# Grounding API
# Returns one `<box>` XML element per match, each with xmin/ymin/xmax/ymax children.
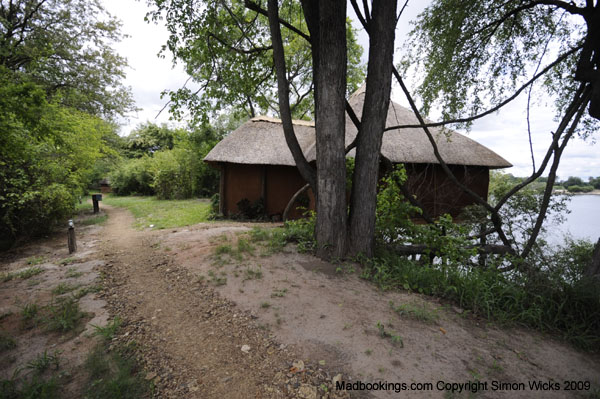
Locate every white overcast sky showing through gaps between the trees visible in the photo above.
<box><xmin>102</xmin><ymin>0</ymin><xmax>600</xmax><ymax>180</ymax></box>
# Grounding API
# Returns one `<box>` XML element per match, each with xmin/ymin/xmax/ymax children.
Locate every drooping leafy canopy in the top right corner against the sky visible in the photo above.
<box><xmin>403</xmin><ymin>0</ymin><xmax>600</xmax><ymax>132</ymax></box>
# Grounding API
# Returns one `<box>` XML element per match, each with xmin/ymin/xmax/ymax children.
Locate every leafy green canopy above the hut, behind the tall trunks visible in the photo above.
<box><xmin>147</xmin><ymin>0</ymin><xmax>364</xmax><ymax>121</ymax></box>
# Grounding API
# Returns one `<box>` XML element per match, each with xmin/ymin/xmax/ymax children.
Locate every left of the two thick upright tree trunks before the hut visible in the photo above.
<box><xmin>312</xmin><ymin>0</ymin><xmax>347</xmax><ymax>258</ymax></box>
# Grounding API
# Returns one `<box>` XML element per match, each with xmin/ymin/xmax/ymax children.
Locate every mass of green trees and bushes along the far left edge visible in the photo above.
<box><xmin>0</xmin><ymin>0</ymin><xmax>133</xmax><ymax>249</ymax></box>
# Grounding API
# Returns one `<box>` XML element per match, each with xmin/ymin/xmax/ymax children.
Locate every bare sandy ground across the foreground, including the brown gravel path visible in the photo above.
<box><xmin>0</xmin><ymin>206</ymin><xmax>600</xmax><ymax>399</ymax></box>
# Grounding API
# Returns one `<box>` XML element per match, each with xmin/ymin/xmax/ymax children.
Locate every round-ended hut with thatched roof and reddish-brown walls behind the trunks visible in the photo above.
<box><xmin>204</xmin><ymin>88</ymin><xmax>512</xmax><ymax>220</ymax></box>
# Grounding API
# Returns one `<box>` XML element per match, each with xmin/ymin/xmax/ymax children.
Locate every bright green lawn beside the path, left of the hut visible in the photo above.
<box><xmin>103</xmin><ymin>195</ymin><xmax>210</xmax><ymax>229</ymax></box>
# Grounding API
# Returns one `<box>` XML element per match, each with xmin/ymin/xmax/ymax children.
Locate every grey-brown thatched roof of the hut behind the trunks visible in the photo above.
<box><xmin>204</xmin><ymin>86</ymin><xmax>512</xmax><ymax>169</ymax></box>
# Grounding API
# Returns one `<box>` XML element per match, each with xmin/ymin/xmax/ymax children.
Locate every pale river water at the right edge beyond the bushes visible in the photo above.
<box><xmin>548</xmin><ymin>195</ymin><xmax>600</xmax><ymax>244</ymax></box>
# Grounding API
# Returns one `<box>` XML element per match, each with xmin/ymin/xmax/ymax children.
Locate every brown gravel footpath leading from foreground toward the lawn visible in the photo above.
<box><xmin>103</xmin><ymin>206</ymin><xmax>346</xmax><ymax>398</ymax></box>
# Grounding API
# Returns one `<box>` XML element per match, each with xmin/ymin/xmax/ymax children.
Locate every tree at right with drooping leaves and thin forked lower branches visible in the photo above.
<box><xmin>397</xmin><ymin>0</ymin><xmax>600</xmax><ymax>266</ymax></box>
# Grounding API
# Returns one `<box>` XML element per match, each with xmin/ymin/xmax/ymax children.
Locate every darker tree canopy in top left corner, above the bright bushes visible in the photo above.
<box><xmin>0</xmin><ymin>0</ymin><xmax>133</xmax><ymax>118</ymax></box>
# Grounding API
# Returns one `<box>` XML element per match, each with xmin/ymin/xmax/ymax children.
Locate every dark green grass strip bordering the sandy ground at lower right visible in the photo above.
<box><xmin>363</xmin><ymin>254</ymin><xmax>600</xmax><ymax>351</ymax></box>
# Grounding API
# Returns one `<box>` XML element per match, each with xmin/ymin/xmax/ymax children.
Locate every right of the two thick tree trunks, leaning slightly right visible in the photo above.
<box><xmin>349</xmin><ymin>0</ymin><xmax>396</xmax><ymax>257</ymax></box>
